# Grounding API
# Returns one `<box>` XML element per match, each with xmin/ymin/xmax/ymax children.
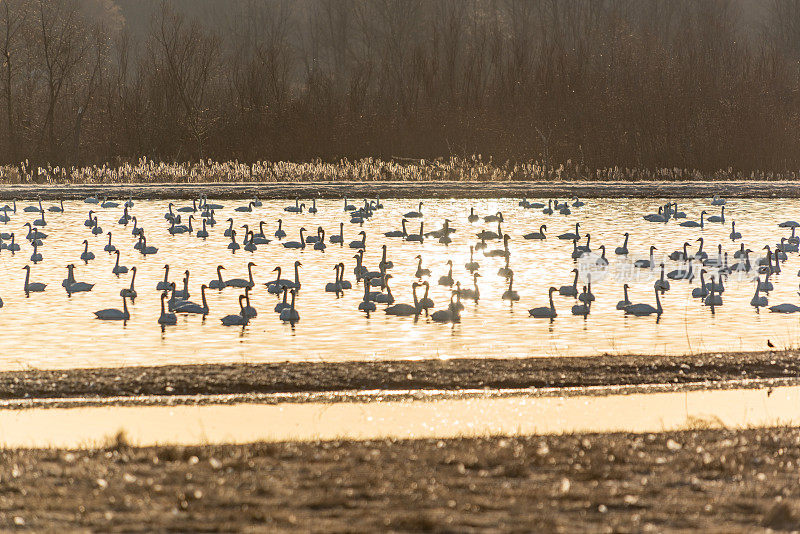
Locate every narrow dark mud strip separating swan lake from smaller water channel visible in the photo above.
<box><xmin>0</xmin><ymin>351</ymin><xmax>800</xmax><ymax>399</ymax></box>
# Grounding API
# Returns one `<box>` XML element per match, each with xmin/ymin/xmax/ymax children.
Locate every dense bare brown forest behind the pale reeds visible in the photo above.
<box><xmin>0</xmin><ymin>0</ymin><xmax>800</xmax><ymax>171</ymax></box>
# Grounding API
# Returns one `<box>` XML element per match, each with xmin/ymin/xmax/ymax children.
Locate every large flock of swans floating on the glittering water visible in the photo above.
<box><xmin>0</xmin><ymin>191</ymin><xmax>800</xmax><ymax>326</ymax></box>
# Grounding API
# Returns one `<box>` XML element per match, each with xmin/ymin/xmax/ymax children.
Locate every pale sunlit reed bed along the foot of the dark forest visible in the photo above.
<box><xmin>0</xmin><ymin>155</ymin><xmax>800</xmax><ymax>185</ymax></box>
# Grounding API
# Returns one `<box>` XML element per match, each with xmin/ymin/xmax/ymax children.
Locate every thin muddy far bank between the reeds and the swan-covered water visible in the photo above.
<box><xmin>0</xmin><ymin>181</ymin><xmax>800</xmax><ymax>200</ymax></box>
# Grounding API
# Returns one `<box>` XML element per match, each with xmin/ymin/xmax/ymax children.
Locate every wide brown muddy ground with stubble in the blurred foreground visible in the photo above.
<box><xmin>0</xmin><ymin>428</ymin><xmax>800</xmax><ymax>532</ymax></box>
